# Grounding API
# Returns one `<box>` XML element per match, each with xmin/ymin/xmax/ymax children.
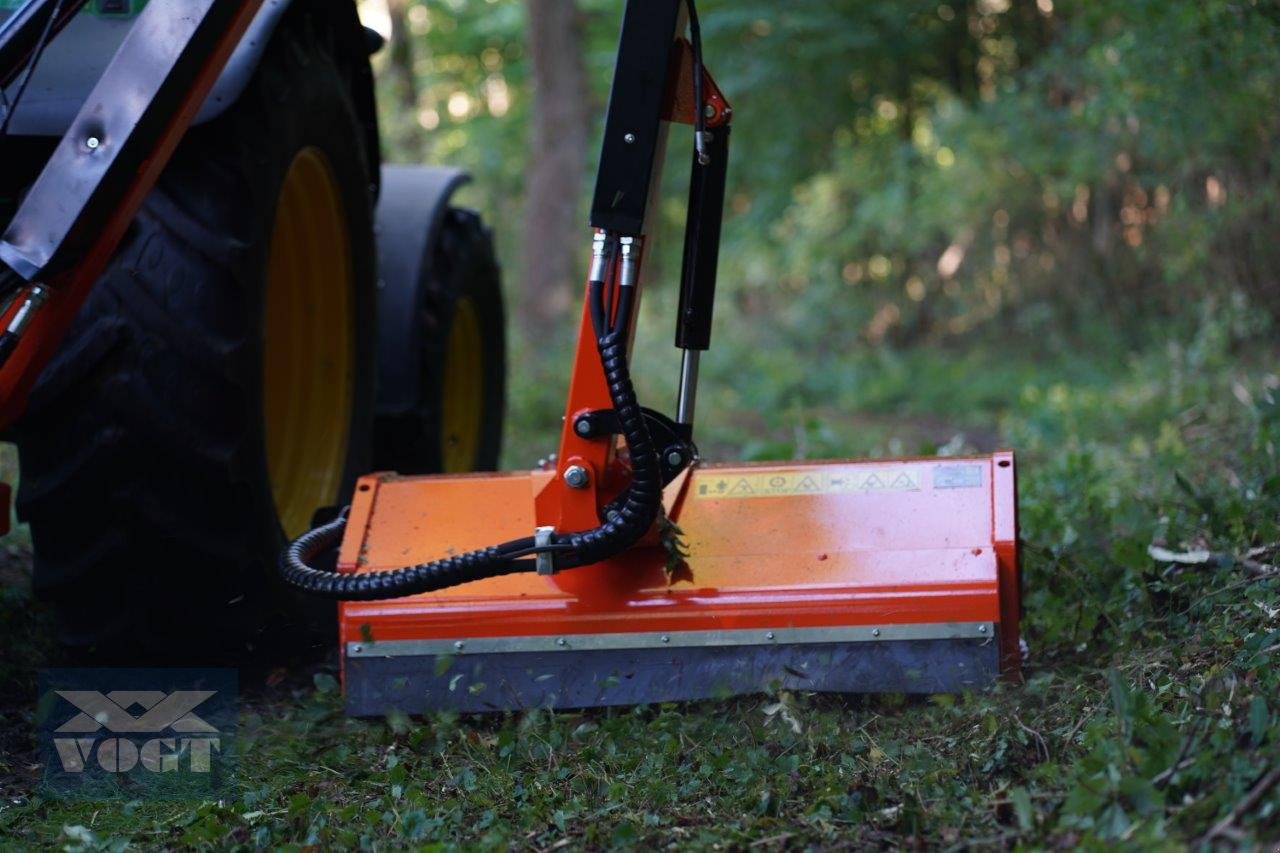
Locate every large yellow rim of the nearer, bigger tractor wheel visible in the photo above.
<box><xmin>262</xmin><ymin>147</ymin><xmax>356</xmax><ymax>537</ymax></box>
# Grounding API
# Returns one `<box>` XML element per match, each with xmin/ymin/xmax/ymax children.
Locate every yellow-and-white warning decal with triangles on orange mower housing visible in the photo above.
<box><xmin>694</xmin><ymin>465</ymin><xmax>922</xmax><ymax>498</ymax></box>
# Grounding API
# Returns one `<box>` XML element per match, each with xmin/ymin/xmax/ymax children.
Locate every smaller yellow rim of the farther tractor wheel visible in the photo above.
<box><xmin>440</xmin><ymin>296</ymin><xmax>484</xmax><ymax>473</ymax></box>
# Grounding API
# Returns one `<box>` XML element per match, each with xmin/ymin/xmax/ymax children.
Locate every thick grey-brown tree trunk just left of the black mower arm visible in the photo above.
<box><xmin>518</xmin><ymin>0</ymin><xmax>591</xmax><ymax>329</ymax></box>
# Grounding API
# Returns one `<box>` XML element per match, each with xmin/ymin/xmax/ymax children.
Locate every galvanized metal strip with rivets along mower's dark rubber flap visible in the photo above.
<box><xmin>346</xmin><ymin>622</ymin><xmax>996</xmax><ymax>657</ymax></box>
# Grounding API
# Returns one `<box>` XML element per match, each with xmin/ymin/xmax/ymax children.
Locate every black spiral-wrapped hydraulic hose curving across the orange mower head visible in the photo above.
<box><xmin>279</xmin><ymin>235</ymin><xmax>662</xmax><ymax>601</ymax></box>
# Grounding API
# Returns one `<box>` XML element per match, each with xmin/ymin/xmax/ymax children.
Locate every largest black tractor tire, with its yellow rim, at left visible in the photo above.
<box><xmin>18</xmin><ymin>0</ymin><xmax>376</xmax><ymax>662</ymax></box>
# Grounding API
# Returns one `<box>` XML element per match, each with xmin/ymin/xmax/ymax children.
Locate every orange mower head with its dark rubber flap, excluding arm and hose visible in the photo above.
<box><xmin>339</xmin><ymin>452</ymin><xmax>1019</xmax><ymax>715</ymax></box>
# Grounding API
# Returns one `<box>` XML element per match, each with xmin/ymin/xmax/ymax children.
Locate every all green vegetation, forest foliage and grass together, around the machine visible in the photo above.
<box><xmin>0</xmin><ymin>0</ymin><xmax>1280</xmax><ymax>849</ymax></box>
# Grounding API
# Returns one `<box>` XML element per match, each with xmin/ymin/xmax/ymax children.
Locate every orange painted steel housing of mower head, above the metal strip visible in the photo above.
<box><xmin>339</xmin><ymin>451</ymin><xmax>1019</xmax><ymax>674</ymax></box>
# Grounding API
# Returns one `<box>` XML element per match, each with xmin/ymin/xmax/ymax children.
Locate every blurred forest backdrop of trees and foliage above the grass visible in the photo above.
<box><xmin>365</xmin><ymin>0</ymin><xmax>1280</xmax><ymax>361</ymax></box>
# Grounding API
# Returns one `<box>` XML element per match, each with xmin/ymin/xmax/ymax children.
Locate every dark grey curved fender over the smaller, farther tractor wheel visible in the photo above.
<box><xmin>374</xmin><ymin>164</ymin><xmax>471</xmax><ymax>415</ymax></box>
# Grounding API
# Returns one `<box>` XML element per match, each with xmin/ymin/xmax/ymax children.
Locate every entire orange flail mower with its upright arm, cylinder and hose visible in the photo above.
<box><xmin>282</xmin><ymin>0</ymin><xmax>1020</xmax><ymax>715</ymax></box>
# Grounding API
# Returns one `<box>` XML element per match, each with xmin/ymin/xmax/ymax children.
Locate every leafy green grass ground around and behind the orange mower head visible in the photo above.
<box><xmin>0</xmin><ymin>306</ymin><xmax>1280</xmax><ymax>849</ymax></box>
